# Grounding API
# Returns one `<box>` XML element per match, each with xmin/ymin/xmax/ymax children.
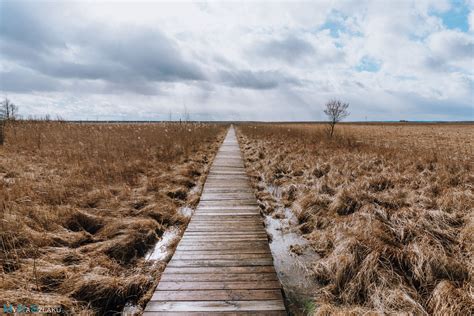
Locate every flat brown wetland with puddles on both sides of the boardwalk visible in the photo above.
<box><xmin>0</xmin><ymin>120</ymin><xmax>474</xmax><ymax>315</ymax></box>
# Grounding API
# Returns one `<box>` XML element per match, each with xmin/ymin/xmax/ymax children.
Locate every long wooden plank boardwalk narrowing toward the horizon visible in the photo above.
<box><xmin>145</xmin><ymin>127</ymin><xmax>286</xmax><ymax>315</ymax></box>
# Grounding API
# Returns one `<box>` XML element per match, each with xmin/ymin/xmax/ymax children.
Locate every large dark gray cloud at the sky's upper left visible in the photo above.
<box><xmin>0</xmin><ymin>2</ymin><xmax>206</xmax><ymax>93</ymax></box>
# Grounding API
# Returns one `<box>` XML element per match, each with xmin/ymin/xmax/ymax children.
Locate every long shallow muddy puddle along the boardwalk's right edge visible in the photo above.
<box><xmin>265</xmin><ymin>186</ymin><xmax>319</xmax><ymax>315</ymax></box>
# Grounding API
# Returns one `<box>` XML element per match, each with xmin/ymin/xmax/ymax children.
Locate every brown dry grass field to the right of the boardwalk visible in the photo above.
<box><xmin>238</xmin><ymin>124</ymin><xmax>474</xmax><ymax>315</ymax></box>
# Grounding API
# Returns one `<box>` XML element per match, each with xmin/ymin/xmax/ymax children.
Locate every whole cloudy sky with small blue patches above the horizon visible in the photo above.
<box><xmin>0</xmin><ymin>0</ymin><xmax>474</xmax><ymax>121</ymax></box>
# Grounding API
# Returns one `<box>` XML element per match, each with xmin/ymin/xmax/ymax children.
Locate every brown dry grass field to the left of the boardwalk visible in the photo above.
<box><xmin>0</xmin><ymin>121</ymin><xmax>225</xmax><ymax>314</ymax></box>
